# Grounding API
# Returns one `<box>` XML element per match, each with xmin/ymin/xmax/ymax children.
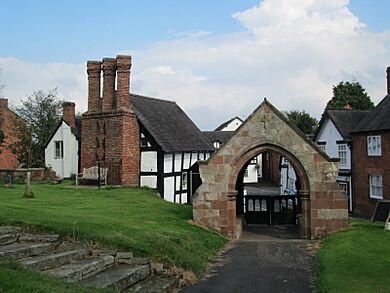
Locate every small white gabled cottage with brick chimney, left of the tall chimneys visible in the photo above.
<box><xmin>45</xmin><ymin>102</ymin><xmax>81</xmax><ymax>178</ymax></box>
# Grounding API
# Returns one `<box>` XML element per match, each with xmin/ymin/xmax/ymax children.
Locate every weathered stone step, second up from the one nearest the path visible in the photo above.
<box><xmin>82</xmin><ymin>265</ymin><xmax>150</xmax><ymax>291</ymax></box>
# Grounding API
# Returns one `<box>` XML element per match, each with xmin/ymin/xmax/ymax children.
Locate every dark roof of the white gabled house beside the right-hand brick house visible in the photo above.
<box><xmin>313</xmin><ymin>110</ymin><xmax>370</xmax><ymax>141</ymax></box>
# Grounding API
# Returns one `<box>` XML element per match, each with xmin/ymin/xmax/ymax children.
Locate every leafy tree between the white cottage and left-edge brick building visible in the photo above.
<box><xmin>11</xmin><ymin>88</ymin><xmax>63</xmax><ymax>167</ymax></box>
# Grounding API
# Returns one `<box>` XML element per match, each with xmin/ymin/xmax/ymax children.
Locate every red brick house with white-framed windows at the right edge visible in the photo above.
<box><xmin>351</xmin><ymin>67</ymin><xmax>390</xmax><ymax>217</ymax></box>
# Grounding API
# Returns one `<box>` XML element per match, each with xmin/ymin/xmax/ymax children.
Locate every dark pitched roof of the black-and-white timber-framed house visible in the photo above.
<box><xmin>130</xmin><ymin>94</ymin><xmax>214</xmax><ymax>153</ymax></box>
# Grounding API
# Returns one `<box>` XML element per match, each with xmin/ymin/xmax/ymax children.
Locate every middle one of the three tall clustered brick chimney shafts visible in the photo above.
<box><xmin>102</xmin><ymin>58</ymin><xmax>116</xmax><ymax>112</ymax></box>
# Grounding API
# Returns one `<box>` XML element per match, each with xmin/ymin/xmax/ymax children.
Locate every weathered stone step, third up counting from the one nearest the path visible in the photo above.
<box><xmin>46</xmin><ymin>255</ymin><xmax>114</xmax><ymax>283</ymax></box>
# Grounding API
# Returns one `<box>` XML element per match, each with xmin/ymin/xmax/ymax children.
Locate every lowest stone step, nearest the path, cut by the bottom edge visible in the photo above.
<box><xmin>124</xmin><ymin>275</ymin><xmax>179</xmax><ymax>293</ymax></box>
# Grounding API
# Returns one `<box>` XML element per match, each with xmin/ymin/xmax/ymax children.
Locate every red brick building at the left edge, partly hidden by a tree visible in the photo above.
<box><xmin>0</xmin><ymin>99</ymin><xmax>22</xmax><ymax>169</ymax></box>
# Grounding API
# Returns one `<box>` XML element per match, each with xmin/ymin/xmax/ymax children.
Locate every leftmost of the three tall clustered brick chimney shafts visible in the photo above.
<box><xmin>87</xmin><ymin>61</ymin><xmax>101</xmax><ymax>112</ymax></box>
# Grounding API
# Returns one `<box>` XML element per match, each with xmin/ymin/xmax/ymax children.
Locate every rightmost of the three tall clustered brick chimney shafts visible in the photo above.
<box><xmin>116</xmin><ymin>55</ymin><xmax>131</xmax><ymax>111</ymax></box>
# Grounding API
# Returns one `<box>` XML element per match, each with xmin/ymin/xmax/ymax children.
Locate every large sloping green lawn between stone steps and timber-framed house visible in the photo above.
<box><xmin>0</xmin><ymin>183</ymin><xmax>226</xmax><ymax>274</ymax></box>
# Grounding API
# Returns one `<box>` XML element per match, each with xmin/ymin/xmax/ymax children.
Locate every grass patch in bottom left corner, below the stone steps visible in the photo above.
<box><xmin>0</xmin><ymin>261</ymin><xmax>115</xmax><ymax>293</ymax></box>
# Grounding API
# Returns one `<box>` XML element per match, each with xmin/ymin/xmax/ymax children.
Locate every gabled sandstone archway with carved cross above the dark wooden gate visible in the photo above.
<box><xmin>193</xmin><ymin>100</ymin><xmax>348</xmax><ymax>238</ymax></box>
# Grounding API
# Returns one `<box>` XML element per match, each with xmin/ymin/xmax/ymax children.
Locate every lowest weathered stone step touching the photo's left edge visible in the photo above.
<box><xmin>0</xmin><ymin>243</ymin><xmax>53</xmax><ymax>259</ymax></box>
